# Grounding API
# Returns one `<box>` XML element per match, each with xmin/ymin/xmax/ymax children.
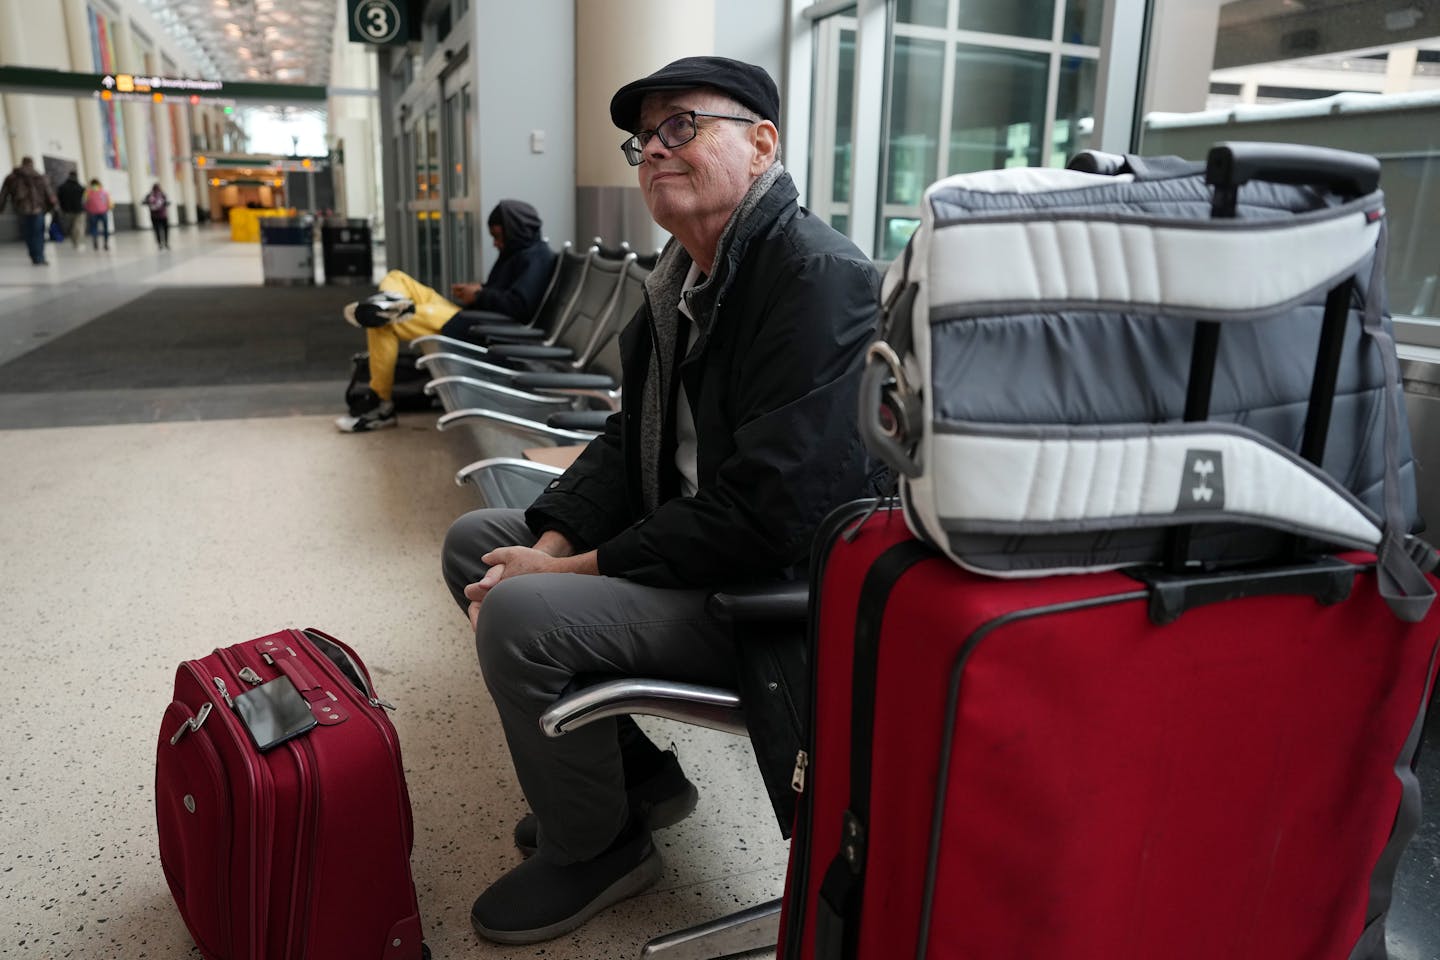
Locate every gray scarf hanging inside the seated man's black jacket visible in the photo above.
<box><xmin>639</xmin><ymin>163</ymin><xmax>785</xmax><ymax>514</ymax></box>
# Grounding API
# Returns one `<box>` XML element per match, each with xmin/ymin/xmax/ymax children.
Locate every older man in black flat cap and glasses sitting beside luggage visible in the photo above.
<box><xmin>444</xmin><ymin>56</ymin><xmax>877</xmax><ymax>943</ymax></box>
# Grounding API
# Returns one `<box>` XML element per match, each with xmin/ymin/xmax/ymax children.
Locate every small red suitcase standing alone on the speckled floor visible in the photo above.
<box><xmin>156</xmin><ymin>630</ymin><xmax>429</xmax><ymax>960</ymax></box>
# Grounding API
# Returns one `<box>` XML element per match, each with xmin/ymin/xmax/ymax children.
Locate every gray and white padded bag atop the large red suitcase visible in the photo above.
<box><xmin>861</xmin><ymin>144</ymin><xmax>1436</xmax><ymax>619</ymax></box>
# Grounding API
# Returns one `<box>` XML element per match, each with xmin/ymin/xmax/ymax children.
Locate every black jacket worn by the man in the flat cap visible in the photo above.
<box><xmin>526</xmin><ymin>173</ymin><xmax>878</xmax><ymax>829</ymax></box>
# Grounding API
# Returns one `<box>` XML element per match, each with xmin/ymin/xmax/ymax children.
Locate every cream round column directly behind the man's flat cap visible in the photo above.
<box><xmin>575</xmin><ymin>0</ymin><xmax>716</xmax><ymax>253</ymax></box>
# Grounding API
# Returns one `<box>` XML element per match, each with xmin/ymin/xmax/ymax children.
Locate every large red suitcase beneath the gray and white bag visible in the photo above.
<box><xmin>779</xmin><ymin>511</ymin><xmax>1440</xmax><ymax>960</ymax></box>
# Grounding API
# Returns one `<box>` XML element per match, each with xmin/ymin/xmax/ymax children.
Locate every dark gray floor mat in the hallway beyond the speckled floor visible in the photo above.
<box><xmin>0</xmin><ymin>286</ymin><xmax>364</xmax><ymax>393</ymax></box>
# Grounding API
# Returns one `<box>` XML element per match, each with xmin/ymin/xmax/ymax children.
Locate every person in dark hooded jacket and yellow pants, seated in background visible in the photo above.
<box><xmin>336</xmin><ymin>200</ymin><xmax>554</xmax><ymax>433</ymax></box>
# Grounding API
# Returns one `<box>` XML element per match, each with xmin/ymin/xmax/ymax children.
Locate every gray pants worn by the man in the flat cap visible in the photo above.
<box><xmin>442</xmin><ymin>510</ymin><xmax>736</xmax><ymax>864</ymax></box>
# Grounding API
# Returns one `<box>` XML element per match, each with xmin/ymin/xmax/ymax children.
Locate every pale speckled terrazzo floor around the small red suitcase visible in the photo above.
<box><xmin>0</xmin><ymin>416</ymin><xmax>785</xmax><ymax>960</ymax></box>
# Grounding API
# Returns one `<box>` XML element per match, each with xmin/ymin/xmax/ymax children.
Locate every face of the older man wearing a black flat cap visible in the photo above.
<box><xmin>636</xmin><ymin>89</ymin><xmax>760</xmax><ymax>233</ymax></box>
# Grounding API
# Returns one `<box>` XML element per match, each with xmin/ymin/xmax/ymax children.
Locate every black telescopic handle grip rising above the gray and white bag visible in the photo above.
<box><xmin>1205</xmin><ymin>141</ymin><xmax>1380</xmax><ymax>197</ymax></box>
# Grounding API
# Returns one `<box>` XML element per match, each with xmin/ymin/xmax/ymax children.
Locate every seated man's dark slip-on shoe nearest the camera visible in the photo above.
<box><xmin>469</xmin><ymin>818</ymin><xmax>661</xmax><ymax>944</ymax></box>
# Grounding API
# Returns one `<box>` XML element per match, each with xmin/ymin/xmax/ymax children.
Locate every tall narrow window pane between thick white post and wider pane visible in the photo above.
<box><xmin>884</xmin><ymin>37</ymin><xmax>945</xmax><ymax>206</ymax></box>
